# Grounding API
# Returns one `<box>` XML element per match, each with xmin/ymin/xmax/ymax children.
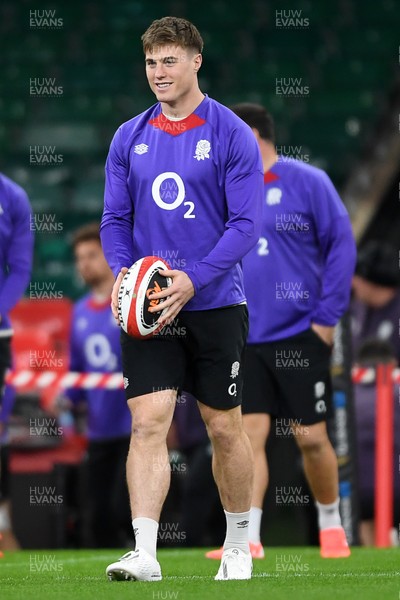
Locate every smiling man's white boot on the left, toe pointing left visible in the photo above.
<box><xmin>106</xmin><ymin>548</ymin><xmax>162</xmax><ymax>581</ymax></box>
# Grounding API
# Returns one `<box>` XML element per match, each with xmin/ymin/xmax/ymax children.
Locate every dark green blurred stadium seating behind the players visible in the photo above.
<box><xmin>0</xmin><ymin>0</ymin><xmax>400</xmax><ymax>298</ymax></box>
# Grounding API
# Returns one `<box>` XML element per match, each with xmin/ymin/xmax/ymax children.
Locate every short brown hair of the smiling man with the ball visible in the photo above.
<box><xmin>142</xmin><ymin>17</ymin><xmax>204</xmax><ymax>53</ymax></box>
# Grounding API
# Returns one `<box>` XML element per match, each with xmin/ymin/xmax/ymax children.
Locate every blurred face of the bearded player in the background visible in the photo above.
<box><xmin>75</xmin><ymin>240</ymin><xmax>111</xmax><ymax>286</ymax></box>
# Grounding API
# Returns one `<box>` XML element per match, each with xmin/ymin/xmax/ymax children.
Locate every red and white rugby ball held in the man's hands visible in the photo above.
<box><xmin>118</xmin><ymin>256</ymin><xmax>172</xmax><ymax>339</ymax></box>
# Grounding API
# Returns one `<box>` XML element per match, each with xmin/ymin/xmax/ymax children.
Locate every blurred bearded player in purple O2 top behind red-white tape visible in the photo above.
<box><xmin>68</xmin><ymin>223</ymin><xmax>131</xmax><ymax>548</ymax></box>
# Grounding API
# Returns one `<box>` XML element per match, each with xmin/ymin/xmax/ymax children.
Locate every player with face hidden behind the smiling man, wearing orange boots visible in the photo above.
<box><xmin>208</xmin><ymin>104</ymin><xmax>356</xmax><ymax>558</ymax></box>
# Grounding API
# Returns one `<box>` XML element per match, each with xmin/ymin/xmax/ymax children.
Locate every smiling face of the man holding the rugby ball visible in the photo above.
<box><xmin>145</xmin><ymin>46</ymin><xmax>201</xmax><ymax>105</ymax></box>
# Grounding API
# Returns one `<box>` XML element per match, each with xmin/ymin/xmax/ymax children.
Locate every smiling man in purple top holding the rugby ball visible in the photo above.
<box><xmin>101</xmin><ymin>17</ymin><xmax>263</xmax><ymax>581</ymax></box>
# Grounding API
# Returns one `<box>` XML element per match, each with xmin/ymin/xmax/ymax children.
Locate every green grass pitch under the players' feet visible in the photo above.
<box><xmin>0</xmin><ymin>546</ymin><xmax>400</xmax><ymax>600</ymax></box>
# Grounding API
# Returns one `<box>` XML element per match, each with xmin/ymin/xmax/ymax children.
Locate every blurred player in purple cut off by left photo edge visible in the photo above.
<box><xmin>0</xmin><ymin>173</ymin><xmax>34</xmax><ymax>552</ymax></box>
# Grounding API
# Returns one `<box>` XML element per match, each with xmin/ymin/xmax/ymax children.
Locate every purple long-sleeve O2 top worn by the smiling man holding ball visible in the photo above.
<box><xmin>101</xmin><ymin>96</ymin><xmax>263</xmax><ymax>310</ymax></box>
